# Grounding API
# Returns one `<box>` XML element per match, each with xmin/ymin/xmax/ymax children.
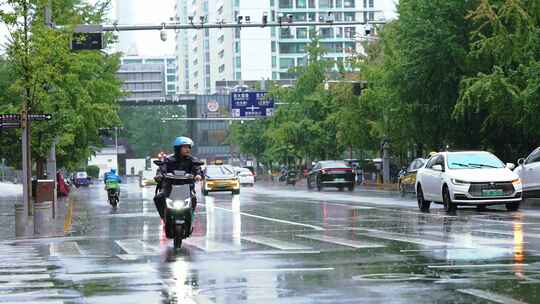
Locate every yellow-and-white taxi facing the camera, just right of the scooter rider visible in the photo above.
<box><xmin>202</xmin><ymin>165</ymin><xmax>240</xmax><ymax>195</ymax></box>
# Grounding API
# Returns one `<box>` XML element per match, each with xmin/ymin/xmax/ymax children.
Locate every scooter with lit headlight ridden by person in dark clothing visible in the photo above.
<box><xmin>154</xmin><ymin>161</ymin><xmax>197</xmax><ymax>249</ymax></box>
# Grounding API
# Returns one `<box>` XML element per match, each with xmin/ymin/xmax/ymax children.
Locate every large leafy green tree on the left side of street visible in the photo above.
<box><xmin>0</xmin><ymin>0</ymin><xmax>122</xmax><ymax>175</ymax></box>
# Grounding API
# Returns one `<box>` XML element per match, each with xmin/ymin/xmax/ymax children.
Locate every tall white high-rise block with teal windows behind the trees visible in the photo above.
<box><xmin>175</xmin><ymin>0</ymin><xmax>394</xmax><ymax>94</ymax></box>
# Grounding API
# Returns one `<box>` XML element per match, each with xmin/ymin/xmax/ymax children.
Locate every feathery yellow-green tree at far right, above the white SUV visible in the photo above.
<box><xmin>454</xmin><ymin>0</ymin><xmax>540</xmax><ymax>159</ymax></box>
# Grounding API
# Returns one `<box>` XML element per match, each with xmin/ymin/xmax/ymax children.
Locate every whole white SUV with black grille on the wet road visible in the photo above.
<box><xmin>416</xmin><ymin>151</ymin><xmax>522</xmax><ymax>212</ymax></box>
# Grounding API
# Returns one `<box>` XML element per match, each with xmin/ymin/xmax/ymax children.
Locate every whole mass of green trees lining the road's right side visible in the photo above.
<box><xmin>229</xmin><ymin>0</ymin><xmax>540</xmax><ymax>166</ymax></box>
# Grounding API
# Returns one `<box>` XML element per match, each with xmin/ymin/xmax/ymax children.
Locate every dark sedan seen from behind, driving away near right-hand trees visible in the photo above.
<box><xmin>307</xmin><ymin>160</ymin><xmax>354</xmax><ymax>191</ymax></box>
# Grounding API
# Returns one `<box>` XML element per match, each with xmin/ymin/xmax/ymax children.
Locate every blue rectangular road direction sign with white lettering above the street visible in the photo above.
<box><xmin>231</xmin><ymin>92</ymin><xmax>274</xmax><ymax>117</ymax></box>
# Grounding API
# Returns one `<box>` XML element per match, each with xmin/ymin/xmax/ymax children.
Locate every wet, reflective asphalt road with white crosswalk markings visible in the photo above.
<box><xmin>0</xmin><ymin>178</ymin><xmax>540</xmax><ymax>304</ymax></box>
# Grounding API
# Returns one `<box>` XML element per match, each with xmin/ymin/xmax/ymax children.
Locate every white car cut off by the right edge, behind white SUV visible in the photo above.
<box><xmin>514</xmin><ymin>147</ymin><xmax>540</xmax><ymax>198</ymax></box>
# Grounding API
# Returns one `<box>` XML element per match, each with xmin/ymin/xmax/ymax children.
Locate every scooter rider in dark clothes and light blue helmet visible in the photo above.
<box><xmin>154</xmin><ymin>136</ymin><xmax>202</xmax><ymax>220</ymax></box>
